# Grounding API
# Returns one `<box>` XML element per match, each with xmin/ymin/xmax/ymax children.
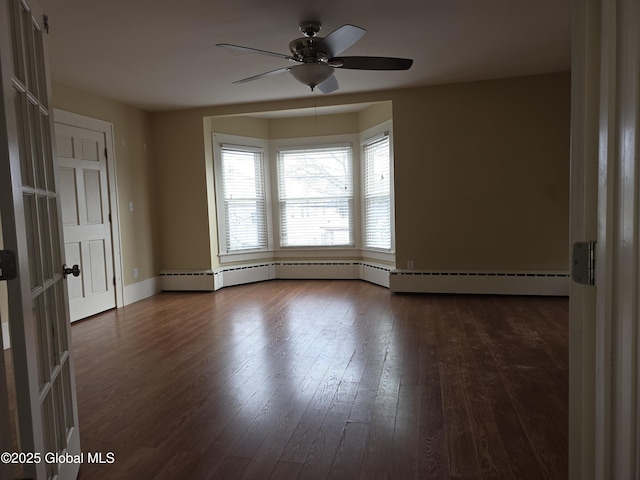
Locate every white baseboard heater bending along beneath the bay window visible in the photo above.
<box><xmin>160</xmin><ymin>261</ymin><xmax>392</xmax><ymax>291</ymax></box>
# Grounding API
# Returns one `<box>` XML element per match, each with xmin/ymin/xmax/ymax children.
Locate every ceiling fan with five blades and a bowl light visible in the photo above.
<box><xmin>216</xmin><ymin>22</ymin><xmax>413</xmax><ymax>93</ymax></box>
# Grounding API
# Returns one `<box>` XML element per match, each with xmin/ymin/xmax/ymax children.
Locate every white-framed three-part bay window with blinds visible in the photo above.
<box><xmin>213</xmin><ymin>125</ymin><xmax>394</xmax><ymax>263</ymax></box>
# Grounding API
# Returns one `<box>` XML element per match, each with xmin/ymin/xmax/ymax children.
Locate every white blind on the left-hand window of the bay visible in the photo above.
<box><xmin>221</xmin><ymin>145</ymin><xmax>267</xmax><ymax>252</ymax></box>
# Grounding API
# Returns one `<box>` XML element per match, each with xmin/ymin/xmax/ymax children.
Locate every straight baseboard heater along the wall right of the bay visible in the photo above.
<box><xmin>389</xmin><ymin>270</ymin><xmax>570</xmax><ymax>296</ymax></box>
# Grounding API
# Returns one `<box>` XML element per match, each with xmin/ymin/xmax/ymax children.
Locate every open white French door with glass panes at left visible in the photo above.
<box><xmin>0</xmin><ymin>0</ymin><xmax>80</xmax><ymax>480</ymax></box>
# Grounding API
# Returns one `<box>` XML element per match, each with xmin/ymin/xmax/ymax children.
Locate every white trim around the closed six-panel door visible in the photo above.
<box><xmin>53</xmin><ymin>108</ymin><xmax>125</xmax><ymax>308</ymax></box>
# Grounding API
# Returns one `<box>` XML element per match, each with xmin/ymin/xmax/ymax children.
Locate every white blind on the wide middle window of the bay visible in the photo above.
<box><xmin>278</xmin><ymin>145</ymin><xmax>354</xmax><ymax>247</ymax></box>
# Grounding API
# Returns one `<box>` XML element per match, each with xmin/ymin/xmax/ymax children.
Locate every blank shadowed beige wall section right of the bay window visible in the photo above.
<box><xmin>393</xmin><ymin>74</ymin><xmax>570</xmax><ymax>270</ymax></box>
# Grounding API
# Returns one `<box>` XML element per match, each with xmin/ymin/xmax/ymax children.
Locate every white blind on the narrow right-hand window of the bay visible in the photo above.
<box><xmin>362</xmin><ymin>134</ymin><xmax>391</xmax><ymax>250</ymax></box>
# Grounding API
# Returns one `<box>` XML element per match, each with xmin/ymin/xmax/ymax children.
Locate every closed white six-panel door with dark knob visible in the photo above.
<box><xmin>55</xmin><ymin>123</ymin><xmax>116</xmax><ymax>322</ymax></box>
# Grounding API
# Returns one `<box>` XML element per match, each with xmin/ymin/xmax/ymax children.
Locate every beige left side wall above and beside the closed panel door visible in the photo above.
<box><xmin>52</xmin><ymin>84</ymin><xmax>161</xmax><ymax>285</ymax></box>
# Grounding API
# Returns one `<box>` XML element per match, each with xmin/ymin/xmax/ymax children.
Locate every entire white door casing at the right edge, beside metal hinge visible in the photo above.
<box><xmin>569</xmin><ymin>0</ymin><xmax>640</xmax><ymax>480</ymax></box>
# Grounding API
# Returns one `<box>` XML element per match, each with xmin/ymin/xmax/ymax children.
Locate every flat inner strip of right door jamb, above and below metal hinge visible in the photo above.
<box><xmin>569</xmin><ymin>0</ymin><xmax>600</xmax><ymax>480</ymax></box>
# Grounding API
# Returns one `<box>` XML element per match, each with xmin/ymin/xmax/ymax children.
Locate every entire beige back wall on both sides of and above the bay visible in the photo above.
<box><xmin>152</xmin><ymin>73</ymin><xmax>570</xmax><ymax>271</ymax></box>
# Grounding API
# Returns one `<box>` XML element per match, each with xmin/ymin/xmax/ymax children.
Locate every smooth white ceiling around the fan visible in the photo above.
<box><xmin>41</xmin><ymin>0</ymin><xmax>571</xmax><ymax>111</ymax></box>
